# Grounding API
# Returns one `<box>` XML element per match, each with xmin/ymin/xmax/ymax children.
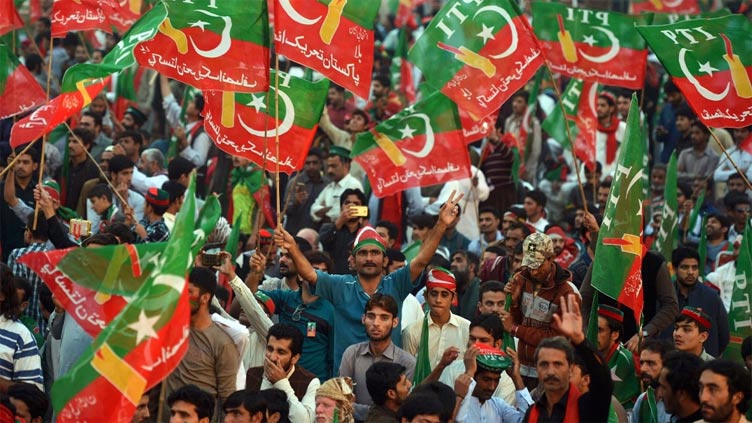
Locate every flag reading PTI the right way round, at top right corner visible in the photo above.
<box><xmin>637</xmin><ymin>15</ymin><xmax>752</xmax><ymax>128</ymax></box>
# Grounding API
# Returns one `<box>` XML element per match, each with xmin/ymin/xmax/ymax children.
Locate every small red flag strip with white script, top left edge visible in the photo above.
<box><xmin>50</xmin><ymin>0</ymin><xmax>114</xmax><ymax>38</ymax></box>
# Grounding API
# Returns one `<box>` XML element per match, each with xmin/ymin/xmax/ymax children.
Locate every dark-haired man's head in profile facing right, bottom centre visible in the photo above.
<box><xmin>365</xmin><ymin>362</ymin><xmax>412</xmax><ymax>423</ymax></box>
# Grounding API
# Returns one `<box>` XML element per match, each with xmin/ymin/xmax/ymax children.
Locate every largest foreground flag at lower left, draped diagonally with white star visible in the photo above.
<box><xmin>50</xmin><ymin>177</ymin><xmax>203</xmax><ymax>422</ymax></box>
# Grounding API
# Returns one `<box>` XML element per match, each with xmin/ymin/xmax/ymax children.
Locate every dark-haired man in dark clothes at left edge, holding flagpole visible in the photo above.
<box><xmin>0</xmin><ymin>147</ymin><xmax>39</xmax><ymax>263</ymax></box>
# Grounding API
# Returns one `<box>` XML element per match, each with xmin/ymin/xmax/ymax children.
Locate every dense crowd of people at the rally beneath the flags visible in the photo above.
<box><xmin>0</xmin><ymin>0</ymin><xmax>752</xmax><ymax>423</ymax></box>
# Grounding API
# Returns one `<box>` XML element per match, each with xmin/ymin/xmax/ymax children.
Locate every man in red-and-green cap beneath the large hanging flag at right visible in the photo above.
<box><xmin>598</xmin><ymin>304</ymin><xmax>640</xmax><ymax>410</ymax></box>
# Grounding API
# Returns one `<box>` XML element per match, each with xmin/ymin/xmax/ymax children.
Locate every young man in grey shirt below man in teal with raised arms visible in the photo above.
<box><xmin>339</xmin><ymin>292</ymin><xmax>415</xmax><ymax>421</ymax></box>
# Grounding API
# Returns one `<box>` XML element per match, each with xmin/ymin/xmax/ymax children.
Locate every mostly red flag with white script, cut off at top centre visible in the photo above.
<box><xmin>274</xmin><ymin>0</ymin><xmax>381</xmax><ymax>99</ymax></box>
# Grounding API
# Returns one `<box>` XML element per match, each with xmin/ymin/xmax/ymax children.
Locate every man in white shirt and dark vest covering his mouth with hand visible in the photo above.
<box><xmin>245</xmin><ymin>323</ymin><xmax>320</xmax><ymax>423</ymax></box>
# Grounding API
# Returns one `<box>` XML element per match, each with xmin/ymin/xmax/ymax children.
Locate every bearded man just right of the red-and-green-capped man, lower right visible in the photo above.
<box><xmin>629</xmin><ymin>339</ymin><xmax>674</xmax><ymax>423</ymax></box>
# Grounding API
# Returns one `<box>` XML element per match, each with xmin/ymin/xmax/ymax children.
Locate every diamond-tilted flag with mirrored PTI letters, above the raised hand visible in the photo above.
<box><xmin>408</xmin><ymin>0</ymin><xmax>543</xmax><ymax>119</ymax></box>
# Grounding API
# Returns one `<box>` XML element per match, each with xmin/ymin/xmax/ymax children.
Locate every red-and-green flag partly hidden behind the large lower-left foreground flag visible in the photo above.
<box><xmin>19</xmin><ymin>243</ymin><xmax>166</xmax><ymax>337</ymax></box>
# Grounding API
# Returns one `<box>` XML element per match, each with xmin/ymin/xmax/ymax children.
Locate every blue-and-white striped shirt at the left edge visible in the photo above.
<box><xmin>0</xmin><ymin>316</ymin><xmax>44</xmax><ymax>390</ymax></box>
